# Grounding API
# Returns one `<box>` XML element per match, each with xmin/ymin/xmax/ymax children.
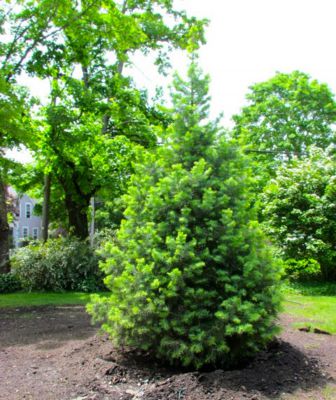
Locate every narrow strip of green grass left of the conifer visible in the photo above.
<box><xmin>0</xmin><ymin>292</ymin><xmax>106</xmax><ymax>308</ymax></box>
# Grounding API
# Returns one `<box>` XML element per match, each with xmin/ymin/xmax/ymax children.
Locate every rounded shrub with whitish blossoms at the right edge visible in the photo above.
<box><xmin>263</xmin><ymin>149</ymin><xmax>336</xmax><ymax>281</ymax></box>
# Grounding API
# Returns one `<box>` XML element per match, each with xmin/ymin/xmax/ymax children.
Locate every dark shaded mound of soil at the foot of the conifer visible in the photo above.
<box><xmin>98</xmin><ymin>340</ymin><xmax>331</xmax><ymax>400</ymax></box>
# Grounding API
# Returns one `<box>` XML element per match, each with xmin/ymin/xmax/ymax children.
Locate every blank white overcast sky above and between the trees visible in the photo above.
<box><xmin>11</xmin><ymin>0</ymin><xmax>336</xmax><ymax>162</ymax></box>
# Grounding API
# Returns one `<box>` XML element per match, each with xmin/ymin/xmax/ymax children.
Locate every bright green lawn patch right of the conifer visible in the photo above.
<box><xmin>283</xmin><ymin>283</ymin><xmax>336</xmax><ymax>334</ymax></box>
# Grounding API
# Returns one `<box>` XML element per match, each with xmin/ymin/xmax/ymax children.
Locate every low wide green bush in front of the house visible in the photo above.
<box><xmin>11</xmin><ymin>238</ymin><xmax>104</xmax><ymax>292</ymax></box>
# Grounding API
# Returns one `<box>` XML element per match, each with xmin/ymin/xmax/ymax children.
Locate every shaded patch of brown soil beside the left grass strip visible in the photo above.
<box><xmin>0</xmin><ymin>305</ymin><xmax>97</xmax><ymax>349</ymax></box>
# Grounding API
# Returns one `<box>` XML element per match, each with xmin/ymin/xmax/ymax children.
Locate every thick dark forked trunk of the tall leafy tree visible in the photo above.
<box><xmin>65</xmin><ymin>194</ymin><xmax>90</xmax><ymax>240</ymax></box>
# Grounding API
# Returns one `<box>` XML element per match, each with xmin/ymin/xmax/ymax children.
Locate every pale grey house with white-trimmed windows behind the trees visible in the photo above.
<box><xmin>11</xmin><ymin>189</ymin><xmax>42</xmax><ymax>247</ymax></box>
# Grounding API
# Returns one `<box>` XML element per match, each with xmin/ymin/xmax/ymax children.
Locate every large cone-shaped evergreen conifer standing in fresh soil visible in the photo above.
<box><xmin>88</xmin><ymin>61</ymin><xmax>280</xmax><ymax>368</ymax></box>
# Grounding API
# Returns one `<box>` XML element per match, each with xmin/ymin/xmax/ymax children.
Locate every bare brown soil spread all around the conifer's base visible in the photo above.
<box><xmin>0</xmin><ymin>306</ymin><xmax>336</xmax><ymax>400</ymax></box>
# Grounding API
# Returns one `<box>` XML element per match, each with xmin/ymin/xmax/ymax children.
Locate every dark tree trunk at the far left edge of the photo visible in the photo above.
<box><xmin>0</xmin><ymin>177</ymin><xmax>10</xmax><ymax>274</ymax></box>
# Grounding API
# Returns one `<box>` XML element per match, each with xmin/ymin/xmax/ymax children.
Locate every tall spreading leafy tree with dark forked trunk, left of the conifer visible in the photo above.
<box><xmin>3</xmin><ymin>0</ymin><xmax>205</xmax><ymax>238</ymax></box>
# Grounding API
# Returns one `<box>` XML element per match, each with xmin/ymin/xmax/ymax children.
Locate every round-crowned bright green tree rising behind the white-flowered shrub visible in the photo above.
<box><xmin>233</xmin><ymin>71</ymin><xmax>336</xmax><ymax>180</ymax></box>
